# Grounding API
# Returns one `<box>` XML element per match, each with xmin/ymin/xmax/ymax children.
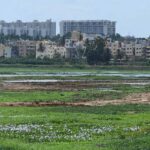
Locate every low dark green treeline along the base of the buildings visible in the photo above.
<box><xmin>0</xmin><ymin>58</ymin><xmax>150</xmax><ymax>66</ymax></box>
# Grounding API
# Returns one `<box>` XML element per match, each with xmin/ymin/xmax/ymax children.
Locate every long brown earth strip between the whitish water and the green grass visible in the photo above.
<box><xmin>0</xmin><ymin>80</ymin><xmax>149</xmax><ymax>91</ymax></box>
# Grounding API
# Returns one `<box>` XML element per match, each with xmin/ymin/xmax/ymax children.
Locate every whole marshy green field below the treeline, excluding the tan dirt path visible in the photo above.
<box><xmin>0</xmin><ymin>65</ymin><xmax>150</xmax><ymax>150</ymax></box>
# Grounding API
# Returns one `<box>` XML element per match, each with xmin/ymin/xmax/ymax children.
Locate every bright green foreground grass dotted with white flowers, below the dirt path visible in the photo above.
<box><xmin>0</xmin><ymin>105</ymin><xmax>150</xmax><ymax>150</ymax></box>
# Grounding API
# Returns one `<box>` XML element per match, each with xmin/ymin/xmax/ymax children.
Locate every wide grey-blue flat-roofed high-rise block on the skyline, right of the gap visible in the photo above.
<box><xmin>60</xmin><ymin>20</ymin><xmax>116</xmax><ymax>36</ymax></box>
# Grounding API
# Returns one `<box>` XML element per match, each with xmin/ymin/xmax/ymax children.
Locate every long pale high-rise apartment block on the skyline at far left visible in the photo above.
<box><xmin>0</xmin><ymin>20</ymin><xmax>56</xmax><ymax>38</ymax></box>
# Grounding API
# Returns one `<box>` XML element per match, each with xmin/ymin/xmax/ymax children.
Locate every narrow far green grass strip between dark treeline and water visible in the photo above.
<box><xmin>0</xmin><ymin>65</ymin><xmax>150</xmax><ymax>74</ymax></box>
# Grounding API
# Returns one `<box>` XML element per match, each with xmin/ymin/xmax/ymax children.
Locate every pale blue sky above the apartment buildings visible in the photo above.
<box><xmin>0</xmin><ymin>0</ymin><xmax>150</xmax><ymax>37</ymax></box>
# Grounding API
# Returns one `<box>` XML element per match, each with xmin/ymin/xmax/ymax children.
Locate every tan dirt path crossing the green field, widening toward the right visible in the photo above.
<box><xmin>0</xmin><ymin>93</ymin><xmax>150</xmax><ymax>107</ymax></box>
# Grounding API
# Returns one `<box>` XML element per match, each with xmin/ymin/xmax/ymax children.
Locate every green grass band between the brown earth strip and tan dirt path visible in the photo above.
<box><xmin>0</xmin><ymin>85</ymin><xmax>150</xmax><ymax>102</ymax></box>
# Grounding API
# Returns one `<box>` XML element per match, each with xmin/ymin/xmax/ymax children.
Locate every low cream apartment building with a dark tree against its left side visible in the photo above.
<box><xmin>36</xmin><ymin>41</ymin><xmax>66</xmax><ymax>59</ymax></box>
